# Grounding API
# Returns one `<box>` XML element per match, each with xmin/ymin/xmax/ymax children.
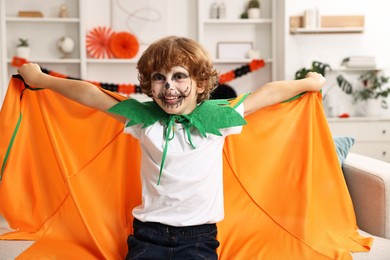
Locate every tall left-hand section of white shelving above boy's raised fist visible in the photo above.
<box><xmin>0</xmin><ymin>0</ymin><xmax>86</xmax><ymax>101</ymax></box>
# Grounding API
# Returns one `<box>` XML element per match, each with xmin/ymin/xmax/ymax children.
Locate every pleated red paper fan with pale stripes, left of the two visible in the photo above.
<box><xmin>86</xmin><ymin>26</ymin><xmax>113</xmax><ymax>59</ymax></box>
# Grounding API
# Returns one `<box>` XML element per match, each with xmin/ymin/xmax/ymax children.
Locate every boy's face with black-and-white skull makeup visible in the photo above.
<box><xmin>152</xmin><ymin>66</ymin><xmax>202</xmax><ymax>115</ymax></box>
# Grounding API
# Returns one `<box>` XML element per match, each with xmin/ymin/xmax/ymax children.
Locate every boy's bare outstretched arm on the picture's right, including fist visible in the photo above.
<box><xmin>244</xmin><ymin>72</ymin><xmax>325</xmax><ymax>115</ymax></box>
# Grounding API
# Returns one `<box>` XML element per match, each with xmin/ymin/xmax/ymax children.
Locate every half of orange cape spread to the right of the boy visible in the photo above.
<box><xmin>218</xmin><ymin>93</ymin><xmax>372</xmax><ymax>259</ymax></box>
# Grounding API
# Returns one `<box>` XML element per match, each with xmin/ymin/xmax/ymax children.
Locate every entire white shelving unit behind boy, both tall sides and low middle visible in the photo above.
<box><xmin>0</xmin><ymin>0</ymin><xmax>277</xmax><ymax>103</ymax></box>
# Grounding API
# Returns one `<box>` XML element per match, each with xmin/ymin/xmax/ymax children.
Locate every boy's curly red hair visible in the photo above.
<box><xmin>137</xmin><ymin>36</ymin><xmax>218</xmax><ymax>102</ymax></box>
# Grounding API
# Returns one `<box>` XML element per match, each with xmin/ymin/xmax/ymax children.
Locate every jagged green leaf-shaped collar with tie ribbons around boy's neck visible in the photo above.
<box><xmin>108</xmin><ymin>96</ymin><xmax>246</xmax><ymax>185</ymax></box>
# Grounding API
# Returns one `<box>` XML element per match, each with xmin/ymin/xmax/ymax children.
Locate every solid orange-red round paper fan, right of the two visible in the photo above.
<box><xmin>109</xmin><ymin>32</ymin><xmax>139</xmax><ymax>59</ymax></box>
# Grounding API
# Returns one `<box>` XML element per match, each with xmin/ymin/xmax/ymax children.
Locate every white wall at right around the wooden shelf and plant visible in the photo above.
<box><xmin>282</xmin><ymin>0</ymin><xmax>390</xmax><ymax>116</ymax></box>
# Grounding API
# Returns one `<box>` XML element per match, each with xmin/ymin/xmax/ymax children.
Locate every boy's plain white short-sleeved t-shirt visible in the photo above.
<box><xmin>124</xmin><ymin>104</ymin><xmax>244</xmax><ymax>226</ymax></box>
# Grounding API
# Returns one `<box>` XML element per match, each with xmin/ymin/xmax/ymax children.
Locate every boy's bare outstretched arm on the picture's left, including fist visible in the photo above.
<box><xmin>18</xmin><ymin>63</ymin><xmax>126</xmax><ymax>123</ymax></box>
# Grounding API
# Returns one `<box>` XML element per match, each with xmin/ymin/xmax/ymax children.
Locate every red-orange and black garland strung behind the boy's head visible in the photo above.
<box><xmin>12</xmin><ymin>57</ymin><xmax>265</xmax><ymax>96</ymax></box>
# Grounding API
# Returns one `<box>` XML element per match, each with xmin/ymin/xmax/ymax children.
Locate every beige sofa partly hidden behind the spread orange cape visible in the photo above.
<box><xmin>0</xmin><ymin>153</ymin><xmax>390</xmax><ymax>260</ymax></box>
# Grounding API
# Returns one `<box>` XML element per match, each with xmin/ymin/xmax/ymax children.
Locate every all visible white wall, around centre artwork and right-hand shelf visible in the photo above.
<box><xmin>74</xmin><ymin>0</ymin><xmax>390</xmax><ymax>115</ymax></box>
